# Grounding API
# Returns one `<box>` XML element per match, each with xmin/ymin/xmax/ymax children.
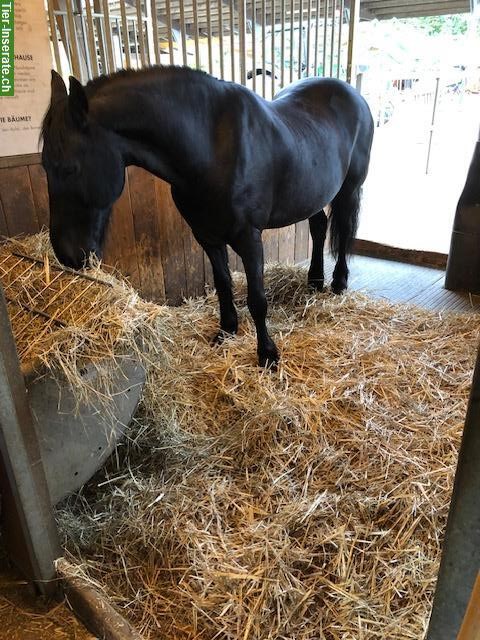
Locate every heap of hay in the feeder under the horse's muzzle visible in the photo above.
<box><xmin>0</xmin><ymin>233</ymin><xmax>161</xmax><ymax>412</ymax></box>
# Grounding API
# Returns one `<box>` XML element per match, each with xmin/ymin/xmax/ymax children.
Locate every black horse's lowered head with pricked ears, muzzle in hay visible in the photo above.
<box><xmin>42</xmin><ymin>71</ymin><xmax>125</xmax><ymax>269</ymax></box>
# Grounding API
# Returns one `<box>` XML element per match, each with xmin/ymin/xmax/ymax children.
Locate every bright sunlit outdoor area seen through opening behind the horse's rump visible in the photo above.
<box><xmin>357</xmin><ymin>14</ymin><xmax>480</xmax><ymax>253</ymax></box>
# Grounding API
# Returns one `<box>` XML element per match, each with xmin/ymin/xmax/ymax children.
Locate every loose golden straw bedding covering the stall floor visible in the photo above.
<box><xmin>58</xmin><ymin>268</ymin><xmax>478</xmax><ymax>640</ymax></box>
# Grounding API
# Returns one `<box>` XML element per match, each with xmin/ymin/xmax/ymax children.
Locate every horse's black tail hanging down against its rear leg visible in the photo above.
<box><xmin>329</xmin><ymin>181</ymin><xmax>362</xmax><ymax>258</ymax></box>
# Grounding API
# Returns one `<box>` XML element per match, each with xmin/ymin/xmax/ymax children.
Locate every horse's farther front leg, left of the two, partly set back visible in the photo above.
<box><xmin>200</xmin><ymin>242</ymin><xmax>238</xmax><ymax>344</ymax></box>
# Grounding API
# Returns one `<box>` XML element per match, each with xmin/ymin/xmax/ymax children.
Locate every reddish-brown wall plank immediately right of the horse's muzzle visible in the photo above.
<box><xmin>104</xmin><ymin>172</ymin><xmax>142</xmax><ymax>288</ymax></box>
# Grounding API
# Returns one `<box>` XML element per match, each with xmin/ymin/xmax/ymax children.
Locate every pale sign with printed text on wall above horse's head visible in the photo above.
<box><xmin>0</xmin><ymin>0</ymin><xmax>52</xmax><ymax>156</ymax></box>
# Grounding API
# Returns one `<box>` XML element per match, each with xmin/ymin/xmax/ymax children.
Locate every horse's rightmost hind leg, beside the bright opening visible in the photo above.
<box><xmin>330</xmin><ymin>179</ymin><xmax>361</xmax><ymax>293</ymax></box>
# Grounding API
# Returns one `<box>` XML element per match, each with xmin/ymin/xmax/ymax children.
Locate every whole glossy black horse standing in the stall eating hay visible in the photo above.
<box><xmin>42</xmin><ymin>67</ymin><xmax>374</xmax><ymax>366</ymax></box>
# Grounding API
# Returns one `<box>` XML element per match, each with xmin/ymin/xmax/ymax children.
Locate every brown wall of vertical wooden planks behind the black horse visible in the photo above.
<box><xmin>0</xmin><ymin>154</ymin><xmax>310</xmax><ymax>304</ymax></box>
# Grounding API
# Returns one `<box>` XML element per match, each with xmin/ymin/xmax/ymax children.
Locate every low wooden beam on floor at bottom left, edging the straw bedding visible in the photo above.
<box><xmin>57</xmin><ymin>558</ymin><xmax>142</xmax><ymax>640</ymax></box>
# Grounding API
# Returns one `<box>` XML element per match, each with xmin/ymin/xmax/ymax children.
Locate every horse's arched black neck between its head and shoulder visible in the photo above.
<box><xmin>93</xmin><ymin>69</ymin><xmax>219</xmax><ymax>186</ymax></box>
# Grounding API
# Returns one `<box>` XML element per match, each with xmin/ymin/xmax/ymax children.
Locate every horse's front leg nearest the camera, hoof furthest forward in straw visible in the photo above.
<box><xmin>232</xmin><ymin>227</ymin><xmax>279</xmax><ymax>368</ymax></box>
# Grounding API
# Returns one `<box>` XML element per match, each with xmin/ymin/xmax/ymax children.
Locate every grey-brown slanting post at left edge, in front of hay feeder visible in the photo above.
<box><xmin>0</xmin><ymin>287</ymin><xmax>61</xmax><ymax>595</ymax></box>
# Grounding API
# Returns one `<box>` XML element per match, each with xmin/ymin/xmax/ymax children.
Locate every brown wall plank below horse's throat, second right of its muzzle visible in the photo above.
<box><xmin>128</xmin><ymin>167</ymin><xmax>165</xmax><ymax>302</ymax></box>
